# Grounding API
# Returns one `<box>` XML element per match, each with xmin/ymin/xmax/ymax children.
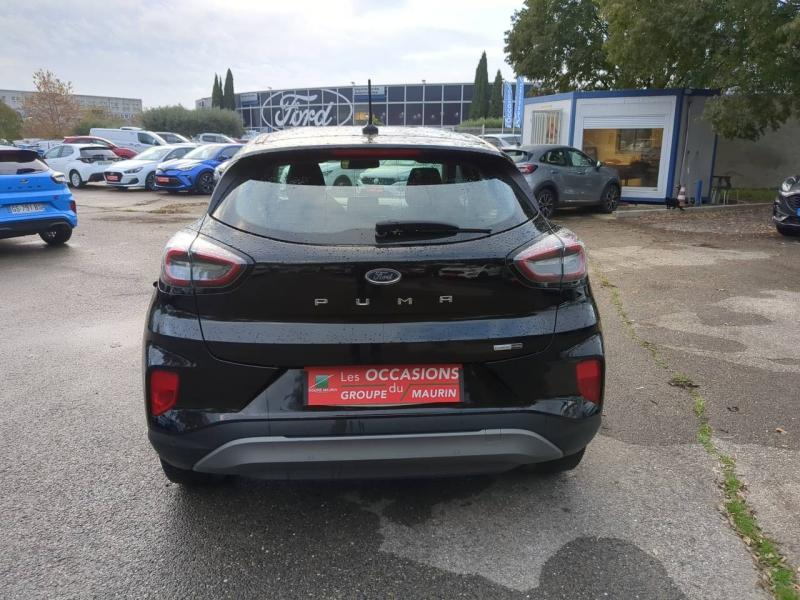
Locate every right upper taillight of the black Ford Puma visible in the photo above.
<box><xmin>514</xmin><ymin>229</ymin><xmax>586</xmax><ymax>283</ymax></box>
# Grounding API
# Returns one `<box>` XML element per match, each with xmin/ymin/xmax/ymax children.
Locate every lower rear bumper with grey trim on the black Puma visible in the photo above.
<box><xmin>149</xmin><ymin>410</ymin><xmax>600</xmax><ymax>479</ymax></box>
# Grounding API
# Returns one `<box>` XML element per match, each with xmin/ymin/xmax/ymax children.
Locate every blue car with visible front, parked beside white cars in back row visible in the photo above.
<box><xmin>155</xmin><ymin>144</ymin><xmax>243</xmax><ymax>194</ymax></box>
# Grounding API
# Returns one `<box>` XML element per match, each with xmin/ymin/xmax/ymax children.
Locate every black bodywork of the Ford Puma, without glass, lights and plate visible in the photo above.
<box><xmin>144</xmin><ymin>128</ymin><xmax>604</xmax><ymax>477</ymax></box>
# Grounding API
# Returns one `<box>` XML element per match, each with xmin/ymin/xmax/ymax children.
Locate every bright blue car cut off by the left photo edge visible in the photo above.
<box><xmin>0</xmin><ymin>146</ymin><xmax>78</xmax><ymax>246</ymax></box>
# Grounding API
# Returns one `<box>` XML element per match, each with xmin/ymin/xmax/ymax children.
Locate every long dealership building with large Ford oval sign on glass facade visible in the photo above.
<box><xmin>195</xmin><ymin>82</ymin><xmax>506</xmax><ymax>131</ymax></box>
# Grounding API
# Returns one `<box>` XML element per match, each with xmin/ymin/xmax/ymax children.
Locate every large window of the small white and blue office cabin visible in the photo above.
<box><xmin>583</xmin><ymin>127</ymin><xmax>664</xmax><ymax>188</ymax></box>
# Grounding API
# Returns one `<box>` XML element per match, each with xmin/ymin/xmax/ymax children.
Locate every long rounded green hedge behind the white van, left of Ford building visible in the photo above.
<box><xmin>142</xmin><ymin>106</ymin><xmax>244</xmax><ymax>137</ymax></box>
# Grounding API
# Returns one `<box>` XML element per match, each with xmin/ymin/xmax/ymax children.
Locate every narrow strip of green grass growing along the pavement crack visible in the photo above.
<box><xmin>598</xmin><ymin>264</ymin><xmax>800</xmax><ymax>600</ymax></box>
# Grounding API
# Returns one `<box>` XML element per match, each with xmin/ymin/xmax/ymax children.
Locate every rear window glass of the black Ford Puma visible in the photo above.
<box><xmin>211</xmin><ymin>153</ymin><xmax>535</xmax><ymax>245</ymax></box>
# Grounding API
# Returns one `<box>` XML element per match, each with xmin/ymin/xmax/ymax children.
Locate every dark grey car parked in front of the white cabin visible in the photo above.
<box><xmin>504</xmin><ymin>144</ymin><xmax>621</xmax><ymax>218</ymax></box>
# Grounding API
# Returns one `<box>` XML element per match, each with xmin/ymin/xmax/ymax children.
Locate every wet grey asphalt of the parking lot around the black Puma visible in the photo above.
<box><xmin>0</xmin><ymin>186</ymin><xmax>788</xmax><ymax>599</ymax></box>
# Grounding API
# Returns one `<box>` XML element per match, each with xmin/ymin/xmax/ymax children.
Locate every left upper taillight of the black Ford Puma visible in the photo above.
<box><xmin>161</xmin><ymin>231</ymin><xmax>247</xmax><ymax>288</ymax></box>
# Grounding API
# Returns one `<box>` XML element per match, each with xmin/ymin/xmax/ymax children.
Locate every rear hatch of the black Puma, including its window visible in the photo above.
<box><xmin>188</xmin><ymin>149</ymin><xmax>561</xmax><ymax>368</ymax></box>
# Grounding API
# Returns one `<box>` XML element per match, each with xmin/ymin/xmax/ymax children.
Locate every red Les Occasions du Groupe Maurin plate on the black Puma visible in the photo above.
<box><xmin>306</xmin><ymin>365</ymin><xmax>462</xmax><ymax>406</ymax></box>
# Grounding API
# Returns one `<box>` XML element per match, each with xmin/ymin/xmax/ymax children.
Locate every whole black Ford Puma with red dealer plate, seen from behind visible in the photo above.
<box><xmin>143</xmin><ymin>127</ymin><xmax>605</xmax><ymax>484</ymax></box>
